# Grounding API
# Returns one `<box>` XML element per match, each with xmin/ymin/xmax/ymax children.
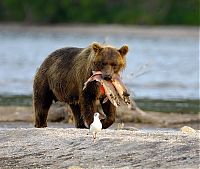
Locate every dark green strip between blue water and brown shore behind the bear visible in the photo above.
<box><xmin>0</xmin><ymin>95</ymin><xmax>200</xmax><ymax>113</ymax></box>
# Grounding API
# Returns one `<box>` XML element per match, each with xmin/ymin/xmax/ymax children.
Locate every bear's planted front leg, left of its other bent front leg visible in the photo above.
<box><xmin>80</xmin><ymin>81</ymin><xmax>99</xmax><ymax>128</ymax></box>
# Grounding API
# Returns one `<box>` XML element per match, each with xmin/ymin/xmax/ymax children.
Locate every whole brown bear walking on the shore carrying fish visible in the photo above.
<box><xmin>33</xmin><ymin>43</ymin><xmax>128</xmax><ymax>129</ymax></box>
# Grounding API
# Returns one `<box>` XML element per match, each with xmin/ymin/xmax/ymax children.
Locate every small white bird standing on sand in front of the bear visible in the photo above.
<box><xmin>90</xmin><ymin>113</ymin><xmax>102</xmax><ymax>139</ymax></box>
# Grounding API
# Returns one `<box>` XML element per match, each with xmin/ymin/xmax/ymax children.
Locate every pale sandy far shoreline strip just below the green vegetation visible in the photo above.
<box><xmin>0</xmin><ymin>23</ymin><xmax>199</xmax><ymax>38</ymax></box>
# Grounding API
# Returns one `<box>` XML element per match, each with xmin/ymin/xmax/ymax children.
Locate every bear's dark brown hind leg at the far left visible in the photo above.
<box><xmin>33</xmin><ymin>86</ymin><xmax>53</xmax><ymax>128</ymax></box>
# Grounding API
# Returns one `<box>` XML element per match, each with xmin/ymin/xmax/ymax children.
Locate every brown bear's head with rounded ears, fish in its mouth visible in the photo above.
<box><xmin>92</xmin><ymin>43</ymin><xmax>128</xmax><ymax>80</ymax></box>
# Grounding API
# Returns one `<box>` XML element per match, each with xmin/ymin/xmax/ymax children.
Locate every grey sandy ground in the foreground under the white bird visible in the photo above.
<box><xmin>0</xmin><ymin>128</ymin><xmax>200</xmax><ymax>169</ymax></box>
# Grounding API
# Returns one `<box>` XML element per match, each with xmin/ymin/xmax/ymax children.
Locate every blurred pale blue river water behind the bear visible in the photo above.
<box><xmin>0</xmin><ymin>24</ymin><xmax>199</xmax><ymax>99</ymax></box>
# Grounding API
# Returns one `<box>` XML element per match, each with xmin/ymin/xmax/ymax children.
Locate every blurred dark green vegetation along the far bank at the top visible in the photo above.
<box><xmin>0</xmin><ymin>0</ymin><xmax>199</xmax><ymax>25</ymax></box>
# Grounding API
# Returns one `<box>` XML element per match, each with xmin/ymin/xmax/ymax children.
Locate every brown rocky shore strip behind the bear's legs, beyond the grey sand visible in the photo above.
<box><xmin>0</xmin><ymin>104</ymin><xmax>200</xmax><ymax>130</ymax></box>
